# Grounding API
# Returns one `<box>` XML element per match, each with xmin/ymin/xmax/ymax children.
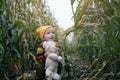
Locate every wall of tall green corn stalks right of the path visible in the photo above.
<box><xmin>64</xmin><ymin>0</ymin><xmax>120</xmax><ymax>80</ymax></box>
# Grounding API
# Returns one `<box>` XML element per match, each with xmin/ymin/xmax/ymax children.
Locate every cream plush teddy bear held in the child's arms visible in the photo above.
<box><xmin>43</xmin><ymin>41</ymin><xmax>63</xmax><ymax>80</ymax></box>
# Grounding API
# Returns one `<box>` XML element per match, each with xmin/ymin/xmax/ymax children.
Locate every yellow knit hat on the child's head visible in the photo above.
<box><xmin>36</xmin><ymin>25</ymin><xmax>52</xmax><ymax>40</ymax></box>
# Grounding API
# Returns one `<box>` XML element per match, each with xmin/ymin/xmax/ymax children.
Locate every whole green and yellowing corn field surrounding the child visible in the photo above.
<box><xmin>0</xmin><ymin>0</ymin><xmax>120</xmax><ymax>80</ymax></box>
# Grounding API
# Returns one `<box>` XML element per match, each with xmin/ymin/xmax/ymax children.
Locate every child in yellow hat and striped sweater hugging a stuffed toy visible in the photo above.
<box><xmin>35</xmin><ymin>25</ymin><xmax>62</xmax><ymax>80</ymax></box>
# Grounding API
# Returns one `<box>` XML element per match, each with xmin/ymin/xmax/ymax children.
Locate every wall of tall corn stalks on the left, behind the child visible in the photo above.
<box><xmin>0</xmin><ymin>0</ymin><xmax>57</xmax><ymax>80</ymax></box>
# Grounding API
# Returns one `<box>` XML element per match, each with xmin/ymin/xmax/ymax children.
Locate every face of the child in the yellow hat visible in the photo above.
<box><xmin>44</xmin><ymin>28</ymin><xmax>55</xmax><ymax>41</ymax></box>
